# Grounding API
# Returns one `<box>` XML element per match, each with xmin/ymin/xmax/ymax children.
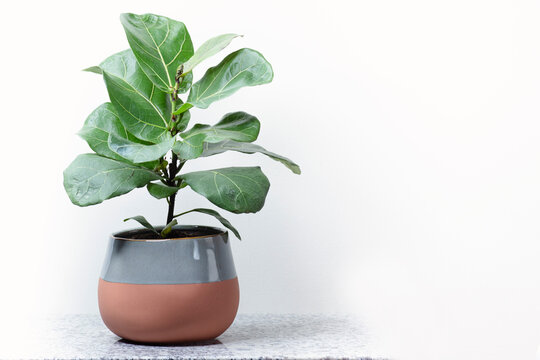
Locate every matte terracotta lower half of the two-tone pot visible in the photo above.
<box><xmin>98</xmin><ymin>277</ymin><xmax>239</xmax><ymax>343</ymax></box>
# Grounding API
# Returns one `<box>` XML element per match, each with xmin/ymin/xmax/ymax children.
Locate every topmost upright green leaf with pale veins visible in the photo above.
<box><xmin>120</xmin><ymin>14</ymin><xmax>193</xmax><ymax>92</ymax></box>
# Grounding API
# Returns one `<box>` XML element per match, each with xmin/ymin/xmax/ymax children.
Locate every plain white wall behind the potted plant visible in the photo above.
<box><xmin>0</xmin><ymin>0</ymin><xmax>540</xmax><ymax>359</ymax></box>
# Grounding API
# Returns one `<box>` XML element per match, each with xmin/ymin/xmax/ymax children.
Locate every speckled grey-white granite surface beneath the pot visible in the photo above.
<box><xmin>0</xmin><ymin>314</ymin><xmax>385</xmax><ymax>359</ymax></box>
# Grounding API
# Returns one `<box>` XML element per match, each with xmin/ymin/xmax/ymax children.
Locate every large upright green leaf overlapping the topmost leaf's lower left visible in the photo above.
<box><xmin>100</xmin><ymin>50</ymin><xmax>171</xmax><ymax>143</ymax></box>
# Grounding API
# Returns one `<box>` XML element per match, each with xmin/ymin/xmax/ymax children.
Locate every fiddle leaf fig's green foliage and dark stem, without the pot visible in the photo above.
<box><xmin>64</xmin><ymin>14</ymin><xmax>300</xmax><ymax>239</ymax></box>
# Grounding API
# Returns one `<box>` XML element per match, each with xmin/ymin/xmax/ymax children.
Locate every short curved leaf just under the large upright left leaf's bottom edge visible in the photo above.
<box><xmin>108</xmin><ymin>134</ymin><xmax>175</xmax><ymax>164</ymax></box>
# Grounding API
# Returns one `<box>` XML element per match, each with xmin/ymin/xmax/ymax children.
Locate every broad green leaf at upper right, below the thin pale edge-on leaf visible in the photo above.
<box><xmin>187</xmin><ymin>49</ymin><xmax>274</xmax><ymax>109</ymax></box>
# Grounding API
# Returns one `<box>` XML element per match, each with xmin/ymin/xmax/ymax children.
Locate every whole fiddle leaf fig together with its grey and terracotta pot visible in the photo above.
<box><xmin>64</xmin><ymin>14</ymin><xmax>300</xmax><ymax>343</ymax></box>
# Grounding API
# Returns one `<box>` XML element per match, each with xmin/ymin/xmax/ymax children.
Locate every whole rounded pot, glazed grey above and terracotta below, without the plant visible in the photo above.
<box><xmin>98</xmin><ymin>226</ymin><xmax>239</xmax><ymax>343</ymax></box>
